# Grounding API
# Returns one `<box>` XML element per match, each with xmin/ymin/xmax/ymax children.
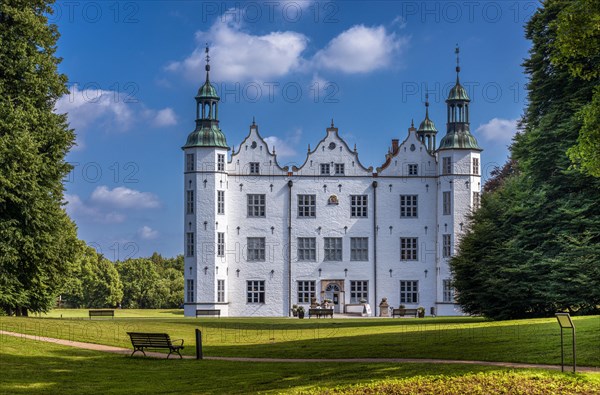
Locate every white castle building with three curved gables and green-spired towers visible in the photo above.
<box><xmin>183</xmin><ymin>49</ymin><xmax>482</xmax><ymax>316</ymax></box>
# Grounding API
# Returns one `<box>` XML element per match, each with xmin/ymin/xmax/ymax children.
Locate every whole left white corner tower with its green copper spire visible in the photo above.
<box><xmin>182</xmin><ymin>46</ymin><xmax>229</xmax><ymax>315</ymax></box>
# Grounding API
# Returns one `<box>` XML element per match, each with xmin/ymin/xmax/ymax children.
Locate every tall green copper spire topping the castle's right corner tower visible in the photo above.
<box><xmin>439</xmin><ymin>44</ymin><xmax>482</xmax><ymax>151</ymax></box>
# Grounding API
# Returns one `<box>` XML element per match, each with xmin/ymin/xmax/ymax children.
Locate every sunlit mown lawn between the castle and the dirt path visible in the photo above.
<box><xmin>0</xmin><ymin>310</ymin><xmax>600</xmax><ymax>367</ymax></box>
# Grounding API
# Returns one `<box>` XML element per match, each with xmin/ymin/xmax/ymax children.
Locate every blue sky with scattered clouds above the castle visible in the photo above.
<box><xmin>50</xmin><ymin>0</ymin><xmax>537</xmax><ymax>260</ymax></box>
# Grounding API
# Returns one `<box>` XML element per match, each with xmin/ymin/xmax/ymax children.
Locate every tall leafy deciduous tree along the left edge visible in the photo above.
<box><xmin>0</xmin><ymin>0</ymin><xmax>77</xmax><ymax>314</ymax></box>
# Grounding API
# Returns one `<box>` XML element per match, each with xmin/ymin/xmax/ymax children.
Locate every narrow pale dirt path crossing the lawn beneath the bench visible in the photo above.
<box><xmin>0</xmin><ymin>330</ymin><xmax>600</xmax><ymax>374</ymax></box>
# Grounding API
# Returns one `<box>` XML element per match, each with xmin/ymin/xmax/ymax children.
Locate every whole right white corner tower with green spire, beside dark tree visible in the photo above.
<box><xmin>436</xmin><ymin>46</ymin><xmax>482</xmax><ymax>312</ymax></box>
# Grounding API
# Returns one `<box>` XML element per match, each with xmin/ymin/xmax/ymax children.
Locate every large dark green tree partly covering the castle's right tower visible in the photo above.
<box><xmin>451</xmin><ymin>0</ymin><xmax>600</xmax><ymax>319</ymax></box>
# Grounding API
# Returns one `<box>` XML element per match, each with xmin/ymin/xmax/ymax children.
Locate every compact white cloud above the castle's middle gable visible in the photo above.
<box><xmin>314</xmin><ymin>25</ymin><xmax>409</xmax><ymax>74</ymax></box>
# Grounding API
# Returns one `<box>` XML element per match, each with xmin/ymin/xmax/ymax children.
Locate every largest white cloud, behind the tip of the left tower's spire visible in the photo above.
<box><xmin>166</xmin><ymin>19</ymin><xmax>308</xmax><ymax>82</ymax></box>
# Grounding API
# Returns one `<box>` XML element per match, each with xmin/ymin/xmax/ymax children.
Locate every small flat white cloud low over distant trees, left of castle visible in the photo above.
<box><xmin>90</xmin><ymin>185</ymin><xmax>160</xmax><ymax>209</ymax></box>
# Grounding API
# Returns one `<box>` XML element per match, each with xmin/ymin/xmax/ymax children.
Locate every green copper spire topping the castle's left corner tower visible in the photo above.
<box><xmin>183</xmin><ymin>44</ymin><xmax>229</xmax><ymax>149</ymax></box>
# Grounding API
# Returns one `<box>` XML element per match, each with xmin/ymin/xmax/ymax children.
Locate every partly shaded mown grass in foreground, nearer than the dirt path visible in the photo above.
<box><xmin>0</xmin><ymin>335</ymin><xmax>600</xmax><ymax>395</ymax></box>
